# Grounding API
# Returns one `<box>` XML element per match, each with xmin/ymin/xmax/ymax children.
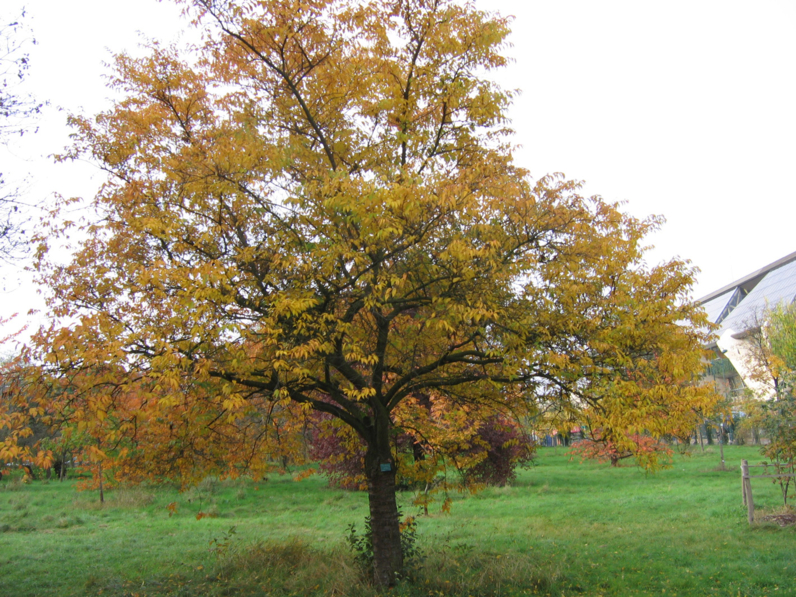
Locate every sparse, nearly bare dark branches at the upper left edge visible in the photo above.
<box><xmin>0</xmin><ymin>10</ymin><xmax>42</xmax><ymax>260</ymax></box>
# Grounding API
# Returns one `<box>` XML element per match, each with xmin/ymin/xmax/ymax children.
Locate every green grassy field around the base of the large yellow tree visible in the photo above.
<box><xmin>0</xmin><ymin>447</ymin><xmax>796</xmax><ymax>597</ymax></box>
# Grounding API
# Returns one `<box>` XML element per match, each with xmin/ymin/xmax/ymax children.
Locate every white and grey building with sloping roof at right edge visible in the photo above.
<box><xmin>697</xmin><ymin>253</ymin><xmax>796</xmax><ymax>397</ymax></box>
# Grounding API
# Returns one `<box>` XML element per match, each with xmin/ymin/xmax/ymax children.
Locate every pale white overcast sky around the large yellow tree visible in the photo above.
<box><xmin>0</xmin><ymin>0</ymin><xmax>796</xmax><ymax>344</ymax></box>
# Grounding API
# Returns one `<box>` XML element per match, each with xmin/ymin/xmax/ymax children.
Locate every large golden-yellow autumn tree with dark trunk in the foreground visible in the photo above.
<box><xmin>18</xmin><ymin>0</ymin><xmax>713</xmax><ymax>585</ymax></box>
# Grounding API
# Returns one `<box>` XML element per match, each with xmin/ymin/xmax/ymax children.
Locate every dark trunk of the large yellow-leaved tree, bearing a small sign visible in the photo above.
<box><xmin>365</xmin><ymin>442</ymin><xmax>403</xmax><ymax>587</ymax></box>
